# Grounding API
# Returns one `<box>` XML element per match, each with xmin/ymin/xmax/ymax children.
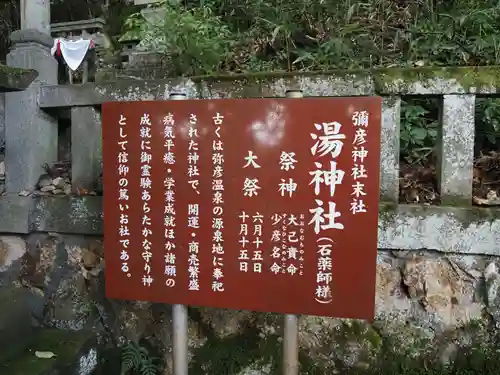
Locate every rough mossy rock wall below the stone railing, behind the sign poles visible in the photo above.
<box><xmin>0</xmin><ymin>233</ymin><xmax>500</xmax><ymax>375</ymax></box>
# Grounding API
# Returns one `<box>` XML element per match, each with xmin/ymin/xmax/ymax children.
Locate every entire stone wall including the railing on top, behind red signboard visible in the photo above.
<box><xmin>0</xmin><ymin>68</ymin><xmax>500</xmax><ymax>375</ymax></box>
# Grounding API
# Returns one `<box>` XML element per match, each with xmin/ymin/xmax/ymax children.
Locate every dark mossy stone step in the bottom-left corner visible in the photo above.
<box><xmin>0</xmin><ymin>329</ymin><xmax>93</xmax><ymax>375</ymax></box>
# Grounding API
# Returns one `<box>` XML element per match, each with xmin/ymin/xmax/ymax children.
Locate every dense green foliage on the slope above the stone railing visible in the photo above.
<box><xmin>123</xmin><ymin>0</ymin><xmax>500</xmax><ymax>75</ymax></box>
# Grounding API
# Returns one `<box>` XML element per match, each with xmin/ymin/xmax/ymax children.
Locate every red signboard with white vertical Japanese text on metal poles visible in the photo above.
<box><xmin>102</xmin><ymin>97</ymin><xmax>381</xmax><ymax>319</ymax></box>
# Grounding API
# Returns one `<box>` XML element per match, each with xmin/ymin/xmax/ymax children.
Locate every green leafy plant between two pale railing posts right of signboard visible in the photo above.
<box><xmin>400</xmin><ymin>101</ymin><xmax>438</xmax><ymax>164</ymax></box>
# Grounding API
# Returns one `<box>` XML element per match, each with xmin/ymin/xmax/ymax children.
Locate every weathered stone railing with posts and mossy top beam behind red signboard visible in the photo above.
<box><xmin>0</xmin><ymin>68</ymin><xmax>500</xmax><ymax>255</ymax></box>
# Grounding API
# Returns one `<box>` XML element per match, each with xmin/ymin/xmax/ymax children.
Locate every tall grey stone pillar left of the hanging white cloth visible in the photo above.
<box><xmin>5</xmin><ymin>0</ymin><xmax>58</xmax><ymax>193</ymax></box>
